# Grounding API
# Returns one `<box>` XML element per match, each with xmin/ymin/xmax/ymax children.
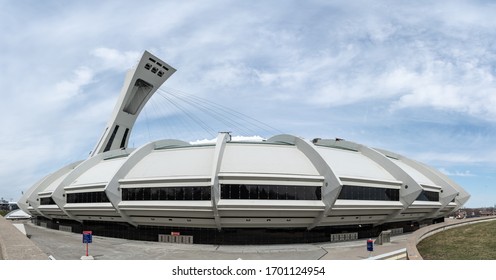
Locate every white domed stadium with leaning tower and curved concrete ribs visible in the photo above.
<box><xmin>18</xmin><ymin>51</ymin><xmax>470</xmax><ymax>244</ymax></box>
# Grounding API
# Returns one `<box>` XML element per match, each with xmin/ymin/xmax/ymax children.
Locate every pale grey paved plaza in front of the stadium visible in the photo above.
<box><xmin>25</xmin><ymin>223</ymin><xmax>409</xmax><ymax>260</ymax></box>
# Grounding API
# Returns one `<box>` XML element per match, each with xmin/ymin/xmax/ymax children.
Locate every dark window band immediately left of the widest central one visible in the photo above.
<box><xmin>122</xmin><ymin>187</ymin><xmax>211</xmax><ymax>201</ymax></box>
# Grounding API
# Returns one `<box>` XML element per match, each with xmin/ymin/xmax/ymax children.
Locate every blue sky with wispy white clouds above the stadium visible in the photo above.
<box><xmin>0</xmin><ymin>0</ymin><xmax>496</xmax><ymax>207</ymax></box>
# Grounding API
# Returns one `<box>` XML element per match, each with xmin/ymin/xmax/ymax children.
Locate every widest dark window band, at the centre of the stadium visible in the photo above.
<box><xmin>220</xmin><ymin>184</ymin><xmax>322</xmax><ymax>200</ymax></box>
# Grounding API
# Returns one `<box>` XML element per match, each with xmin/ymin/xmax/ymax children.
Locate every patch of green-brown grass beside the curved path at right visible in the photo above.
<box><xmin>417</xmin><ymin>221</ymin><xmax>496</xmax><ymax>260</ymax></box>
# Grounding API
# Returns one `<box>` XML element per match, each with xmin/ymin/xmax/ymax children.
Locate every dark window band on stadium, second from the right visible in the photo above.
<box><xmin>338</xmin><ymin>185</ymin><xmax>400</xmax><ymax>201</ymax></box>
